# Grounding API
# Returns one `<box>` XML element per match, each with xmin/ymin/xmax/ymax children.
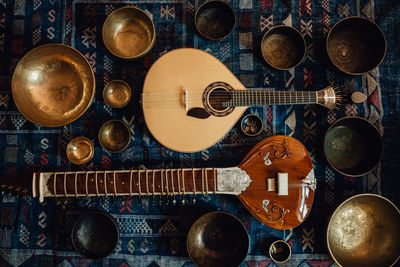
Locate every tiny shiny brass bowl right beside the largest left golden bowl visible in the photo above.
<box><xmin>103</xmin><ymin>80</ymin><xmax>132</xmax><ymax>108</ymax></box>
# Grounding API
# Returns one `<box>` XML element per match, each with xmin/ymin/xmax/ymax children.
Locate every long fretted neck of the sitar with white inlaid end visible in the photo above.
<box><xmin>32</xmin><ymin>167</ymin><xmax>250</xmax><ymax>202</ymax></box>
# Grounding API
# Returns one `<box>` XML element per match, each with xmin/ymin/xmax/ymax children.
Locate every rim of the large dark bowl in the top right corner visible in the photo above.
<box><xmin>325</xmin><ymin>16</ymin><xmax>387</xmax><ymax>75</ymax></box>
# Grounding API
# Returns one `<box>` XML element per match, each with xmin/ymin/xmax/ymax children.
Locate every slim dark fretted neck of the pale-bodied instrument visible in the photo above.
<box><xmin>228</xmin><ymin>89</ymin><xmax>323</xmax><ymax>107</ymax></box>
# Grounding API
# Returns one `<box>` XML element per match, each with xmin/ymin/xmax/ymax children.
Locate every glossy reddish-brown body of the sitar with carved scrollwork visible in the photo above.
<box><xmin>238</xmin><ymin>136</ymin><xmax>316</xmax><ymax>229</ymax></box>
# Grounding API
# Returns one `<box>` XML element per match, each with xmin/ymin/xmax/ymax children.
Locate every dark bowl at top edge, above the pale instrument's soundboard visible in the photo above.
<box><xmin>194</xmin><ymin>1</ymin><xmax>236</xmax><ymax>40</ymax></box>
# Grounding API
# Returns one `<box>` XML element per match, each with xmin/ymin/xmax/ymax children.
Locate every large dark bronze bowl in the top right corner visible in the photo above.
<box><xmin>326</xmin><ymin>17</ymin><xmax>386</xmax><ymax>75</ymax></box>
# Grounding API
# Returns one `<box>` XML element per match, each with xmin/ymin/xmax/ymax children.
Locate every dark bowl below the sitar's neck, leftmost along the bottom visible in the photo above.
<box><xmin>71</xmin><ymin>212</ymin><xmax>119</xmax><ymax>259</ymax></box>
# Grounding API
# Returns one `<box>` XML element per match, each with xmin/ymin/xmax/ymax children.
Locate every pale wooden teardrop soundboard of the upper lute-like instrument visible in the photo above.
<box><xmin>142</xmin><ymin>48</ymin><xmax>246</xmax><ymax>152</ymax></box>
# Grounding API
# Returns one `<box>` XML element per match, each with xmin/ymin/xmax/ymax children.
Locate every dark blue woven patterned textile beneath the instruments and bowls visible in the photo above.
<box><xmin>0</xmin><ymin>0</ymin><xmax>400</xmax><ymax>267</ymax></box>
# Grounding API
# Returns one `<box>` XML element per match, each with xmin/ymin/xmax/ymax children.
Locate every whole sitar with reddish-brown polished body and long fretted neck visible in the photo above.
<box><xmin>0</xmin><ymin>136</ymin><xmax>316</xmax><ymax>229</ymax></box>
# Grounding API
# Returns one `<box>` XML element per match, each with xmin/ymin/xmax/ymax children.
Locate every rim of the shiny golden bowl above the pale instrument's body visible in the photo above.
<box><xmin>101</xmin><ymin>6</ymin><xmax>156</xmax><ymax>60</ymax></box>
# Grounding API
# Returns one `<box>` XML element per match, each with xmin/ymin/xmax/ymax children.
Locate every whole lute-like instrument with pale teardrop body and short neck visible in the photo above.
<box><xmin>141</xmin><ymin>48</ymin><xmax>342</xmax><ymax>152</ymax></box>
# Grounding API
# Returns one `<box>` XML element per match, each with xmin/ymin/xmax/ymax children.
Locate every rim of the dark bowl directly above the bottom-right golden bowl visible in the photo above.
<box><xmin>322</xmin><ymin>116</ymin><xmax>383</xmax><ymax>177</ymax></box>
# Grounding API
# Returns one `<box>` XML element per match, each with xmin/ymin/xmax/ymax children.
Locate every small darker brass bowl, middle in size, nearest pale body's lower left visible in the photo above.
<box><xmin>99</xmin><ymin>120</ymin><xmax>131</xmax><ymax>153</ymax></box>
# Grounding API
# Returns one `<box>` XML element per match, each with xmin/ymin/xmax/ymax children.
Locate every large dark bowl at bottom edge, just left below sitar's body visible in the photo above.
<box><xmin>187</xmin><ymin>212</ymin><xmax>250</xmax><ymax>267</ymax></box>
